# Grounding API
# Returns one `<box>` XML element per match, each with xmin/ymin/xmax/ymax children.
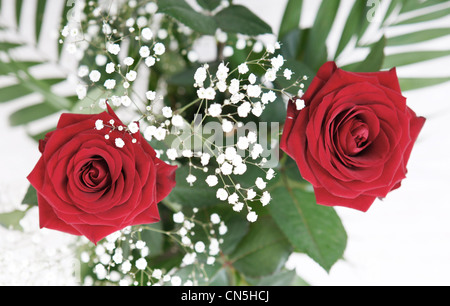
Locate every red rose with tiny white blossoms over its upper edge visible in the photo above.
<box><xmin>28</xmin><ymin>106</ymin><xmax>176</xmax><ymax>243</ymax></box>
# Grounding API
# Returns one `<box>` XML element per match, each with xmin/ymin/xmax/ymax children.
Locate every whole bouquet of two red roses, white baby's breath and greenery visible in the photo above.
<box><xmin>0</xmin><ymin>0</ymin><xmax>449</xmax><ymax>286</ymax></box>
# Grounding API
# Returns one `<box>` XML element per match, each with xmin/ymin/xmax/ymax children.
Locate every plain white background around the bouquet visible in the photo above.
<box><xmin>0</xmin><ymin>0</ymin><xmax>450</xmax><ymax>286</ymax></box>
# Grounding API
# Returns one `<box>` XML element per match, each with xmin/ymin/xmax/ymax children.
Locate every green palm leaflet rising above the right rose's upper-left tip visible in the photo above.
<box><xmin>304</xmin><ymin>0</ymin><xmax>341</xmax><ymax>71</ymax></box>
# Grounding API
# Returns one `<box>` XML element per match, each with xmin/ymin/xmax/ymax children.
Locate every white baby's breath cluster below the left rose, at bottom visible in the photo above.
<box><xmin>81</xmin><ymin>209</ymin><xmax>228</xmax><ymax>286</ymax></box>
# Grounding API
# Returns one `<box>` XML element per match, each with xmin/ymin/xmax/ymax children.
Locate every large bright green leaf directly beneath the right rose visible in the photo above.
<box><xmin>268</xmin><ymin>173</ymin><xmax>347</xmax><ymax>271</ymax></box>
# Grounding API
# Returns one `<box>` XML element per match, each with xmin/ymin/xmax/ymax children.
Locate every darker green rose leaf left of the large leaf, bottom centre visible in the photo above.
<box><xmin>230</xmin><ymin>216</ymin><xmax>292</xmax><ymax>278</ymax></box>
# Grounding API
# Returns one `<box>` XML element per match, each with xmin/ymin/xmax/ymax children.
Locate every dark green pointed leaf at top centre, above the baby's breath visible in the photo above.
<box><xmin>214</xmin><ymin>5</ymin><xmax>272</xmax><ymax>36</ymax></box>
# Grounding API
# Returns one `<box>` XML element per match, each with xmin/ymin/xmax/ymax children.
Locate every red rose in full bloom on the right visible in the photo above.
<box><xmin>281</xmin><ymin>62</ymin><xmax>425</xmax><ymax>212</ymax></box>
